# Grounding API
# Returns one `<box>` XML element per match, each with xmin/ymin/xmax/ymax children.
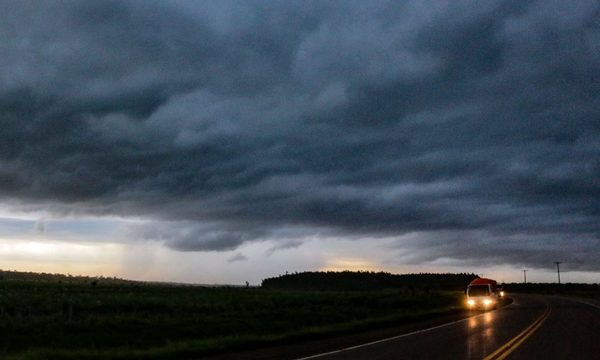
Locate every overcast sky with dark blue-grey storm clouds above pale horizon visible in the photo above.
<box><xmin>0</xmin><ymin>0</ymin><xmax>600</xmax><ymax>282</ymax></box>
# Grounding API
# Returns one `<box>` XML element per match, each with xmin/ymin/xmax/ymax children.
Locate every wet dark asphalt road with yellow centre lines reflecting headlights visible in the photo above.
<box><xmin>205</xmin><ymin>295</ymin><xmax>600</xmax><ymax>360</ymax></box>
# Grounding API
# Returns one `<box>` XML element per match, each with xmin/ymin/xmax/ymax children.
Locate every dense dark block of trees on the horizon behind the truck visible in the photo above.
<box><xmin>261</xmin><ymin>271</ymin><xmax>479</xmax><ymax>293</ymax></box>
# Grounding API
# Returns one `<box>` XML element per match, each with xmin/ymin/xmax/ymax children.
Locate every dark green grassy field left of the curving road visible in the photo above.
<box><xmin>0</xmin><ymin>279</ymin><xmax>461</xmax><ymax>359</ymax></box>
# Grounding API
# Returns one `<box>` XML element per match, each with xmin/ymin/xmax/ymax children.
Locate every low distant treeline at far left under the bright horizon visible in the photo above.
<box><xmin>0</xmin><ymin>270</ymin><xmax>135</xmax><ymax>285</ymax></box>
